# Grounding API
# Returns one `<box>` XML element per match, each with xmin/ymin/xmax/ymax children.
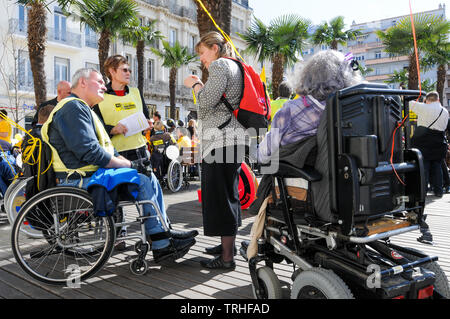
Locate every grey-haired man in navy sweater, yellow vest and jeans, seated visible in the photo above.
<box><xmin>42</xmin><ymin>69</ymin><xmax>196</xmax><ymax>262</ymax></box>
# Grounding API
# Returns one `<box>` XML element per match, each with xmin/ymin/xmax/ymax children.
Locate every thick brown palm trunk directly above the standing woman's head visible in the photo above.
<box><xmin>195</xmin><ymin>0</ymin><xmax>232</xmax><ymax>83</ymax></box>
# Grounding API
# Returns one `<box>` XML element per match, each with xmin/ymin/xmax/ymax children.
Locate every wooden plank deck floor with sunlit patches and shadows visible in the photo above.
<box><xmin>0</xmin><ymin>183</ymin><xmax>450</xmax><ymax>299</ymax></box>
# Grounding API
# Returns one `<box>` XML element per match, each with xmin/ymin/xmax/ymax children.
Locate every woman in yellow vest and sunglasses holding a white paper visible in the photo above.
<box><xmin>94</xmin><ymin>55</ymin><xmax>153</xmax><ymax>161</ymax></box>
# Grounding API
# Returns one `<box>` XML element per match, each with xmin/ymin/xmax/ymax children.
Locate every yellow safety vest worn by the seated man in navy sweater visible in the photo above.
<box><xmin>41</xmin><ymin>97</ymin><xmax>114</xmax><ymax>176</ymax></box>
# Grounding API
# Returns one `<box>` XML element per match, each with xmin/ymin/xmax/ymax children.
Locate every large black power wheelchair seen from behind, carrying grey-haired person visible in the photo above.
<box><xmin>244</xmin><ymin>84</ymin><xmax>450</xmax><ymax>299</ymax></box>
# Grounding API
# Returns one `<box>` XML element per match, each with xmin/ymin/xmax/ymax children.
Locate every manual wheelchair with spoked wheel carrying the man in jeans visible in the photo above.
<box><xmin>11</xmin><ymin>161</ymin><xmax>178</xmax><ymax>285</ymax></box>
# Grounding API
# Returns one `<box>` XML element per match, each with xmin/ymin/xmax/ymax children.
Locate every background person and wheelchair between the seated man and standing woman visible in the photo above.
<box><xmin>149</xmin><ymin>122</ymin><xmax>183</xmax><ymax>192</ymax></box>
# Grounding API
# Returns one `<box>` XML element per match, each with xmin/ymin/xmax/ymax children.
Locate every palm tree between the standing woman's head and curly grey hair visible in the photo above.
<box><xmin>240</xmin><ymin>14</ymin><xmax>310</xmax><ymax>99</ymax></box>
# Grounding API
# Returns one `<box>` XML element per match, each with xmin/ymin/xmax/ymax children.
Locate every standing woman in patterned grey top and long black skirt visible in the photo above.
<box><xmin>184</xmin><ymin>32</ymin><xmax>245</xmax><ymax>270</ymax></box>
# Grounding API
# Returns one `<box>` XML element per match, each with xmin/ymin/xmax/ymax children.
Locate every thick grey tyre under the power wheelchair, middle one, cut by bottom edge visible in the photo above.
<box><xmin>291</xmin><ymin>268</ymin><xmax>354</xmax><ymax>299</ymax></box>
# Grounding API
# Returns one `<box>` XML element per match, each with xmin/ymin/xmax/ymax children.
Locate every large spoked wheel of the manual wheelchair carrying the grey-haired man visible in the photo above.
<box><xmin>11</xmin><ymin>187</ymin><xmax>115</xmax><ymax>285</ymax></box>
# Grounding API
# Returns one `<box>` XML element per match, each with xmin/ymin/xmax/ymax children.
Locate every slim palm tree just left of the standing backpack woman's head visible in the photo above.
<box><xmin>151</xmin><ymin>41</ymin><xmax>197</xmax><ymax>119</ymax></box>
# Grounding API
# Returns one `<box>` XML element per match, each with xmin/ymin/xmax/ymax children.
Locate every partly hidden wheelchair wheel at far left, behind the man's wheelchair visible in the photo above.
<box><xmin>4</xmin><ymin>177</ymin><xmax>43</xmax><ymax>238</ymax></box>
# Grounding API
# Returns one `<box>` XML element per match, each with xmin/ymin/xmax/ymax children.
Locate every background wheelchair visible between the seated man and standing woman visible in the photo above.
<box><xmin>150</xmin><ymin>142</ymin><xmax>186</xmax><ymax>193</ymax></box>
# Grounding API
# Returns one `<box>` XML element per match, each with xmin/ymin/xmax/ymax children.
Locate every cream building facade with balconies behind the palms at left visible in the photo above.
<box><xmin>0</xmin><ymin>0</ymin><xmax>252</xmax><ymax>130</ymax></box>
